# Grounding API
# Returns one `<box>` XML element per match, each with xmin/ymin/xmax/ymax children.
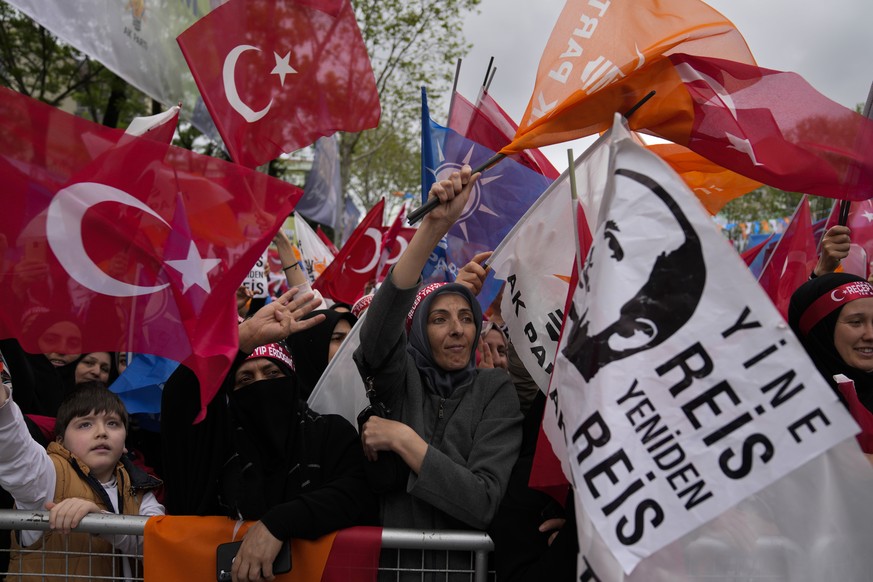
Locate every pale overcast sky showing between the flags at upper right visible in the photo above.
<box><xmin>456</xmin><ymin>0</ymin><xmax>873</xmax><ymax>171</ymax></box>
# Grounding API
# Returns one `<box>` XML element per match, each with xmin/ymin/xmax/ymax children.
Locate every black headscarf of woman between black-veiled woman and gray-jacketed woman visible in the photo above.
<box><xmin>286</xmin><ymin>309</ymin><xmax>358</xmax><ymax>400</ymax></box>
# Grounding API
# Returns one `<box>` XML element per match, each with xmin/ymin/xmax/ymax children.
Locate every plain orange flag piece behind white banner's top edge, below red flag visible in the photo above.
<box><xmin>646</xmin><ymin>143</ymin><xmax>761</xmax><ymax>216</ymax></box>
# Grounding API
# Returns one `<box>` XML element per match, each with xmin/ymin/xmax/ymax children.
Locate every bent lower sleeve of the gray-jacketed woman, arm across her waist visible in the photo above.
<box><xmin>408</xmin><ymin>376</ymin><xmax>522</xmax><ymax>529</ymax></box>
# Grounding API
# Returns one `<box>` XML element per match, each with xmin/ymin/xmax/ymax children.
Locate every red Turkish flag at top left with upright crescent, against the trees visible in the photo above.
<box><xmin>177</xmin><ymin>0</ymin><xmax>380</xmax><ymax>167</ymax></box>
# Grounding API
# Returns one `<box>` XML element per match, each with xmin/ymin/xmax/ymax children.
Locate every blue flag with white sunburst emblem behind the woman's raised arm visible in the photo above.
<box><xmin>421</xmin><ymin>90</ymin><xmax>552</xmax><ymax>308</ymax></box>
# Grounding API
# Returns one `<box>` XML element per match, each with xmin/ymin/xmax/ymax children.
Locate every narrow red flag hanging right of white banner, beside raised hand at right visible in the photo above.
<box><xmin>758</xmin><ymin>196</ymin><xmax>818</xmax><ymax>321</ymax></box>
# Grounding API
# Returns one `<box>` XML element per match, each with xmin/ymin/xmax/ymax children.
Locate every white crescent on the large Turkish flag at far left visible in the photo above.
<box><xmin>45</xmin><ymin>182</ymin><xmax>170</xmax><ymax>297</ymax></box>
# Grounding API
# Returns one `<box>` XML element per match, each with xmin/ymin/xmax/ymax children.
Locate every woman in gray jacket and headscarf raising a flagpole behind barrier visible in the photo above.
<box><xmin>355</xmin><ymin>166</ymin><xmax>522</xmax><ymax>529</ymax></box>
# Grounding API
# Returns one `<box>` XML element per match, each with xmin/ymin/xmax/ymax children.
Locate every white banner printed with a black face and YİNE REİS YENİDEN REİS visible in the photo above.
<box><xmin>550</xmin><ymin>117</ymin><xmax>857</xmax><ymax>574</ymax></box>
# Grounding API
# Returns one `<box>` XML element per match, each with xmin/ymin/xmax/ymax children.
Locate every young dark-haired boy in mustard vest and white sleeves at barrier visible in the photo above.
<box><xmin>0</xmin><ymin>382</ymin><xmax>164</xmax><ymax>577</ymax></box>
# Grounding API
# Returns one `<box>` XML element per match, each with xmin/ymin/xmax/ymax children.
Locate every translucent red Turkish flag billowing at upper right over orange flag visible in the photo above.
<box><xmin>664</xmin><ymin>55</ymin><xmax>873</xmax><ymax>200</ymax></box>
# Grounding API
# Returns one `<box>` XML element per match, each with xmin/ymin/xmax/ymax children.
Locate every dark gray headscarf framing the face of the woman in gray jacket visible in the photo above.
<box><xmin>406</xmin><ymin>283</ymin><xmax>482</xmax><ymax>398</ymax></box>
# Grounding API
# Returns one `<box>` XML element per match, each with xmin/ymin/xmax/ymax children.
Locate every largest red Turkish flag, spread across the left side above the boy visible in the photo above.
<box><xmin>0</xmin><ymin>89</ymin><xmax>302</xmax><ymax>422</ymax></box>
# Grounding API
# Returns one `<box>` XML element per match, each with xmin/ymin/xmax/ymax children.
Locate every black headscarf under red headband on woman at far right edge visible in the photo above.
<box><xmin>788</xmin><ymin>273</ymin><xmax>873</xmax><ymax>411</ymax></box>
